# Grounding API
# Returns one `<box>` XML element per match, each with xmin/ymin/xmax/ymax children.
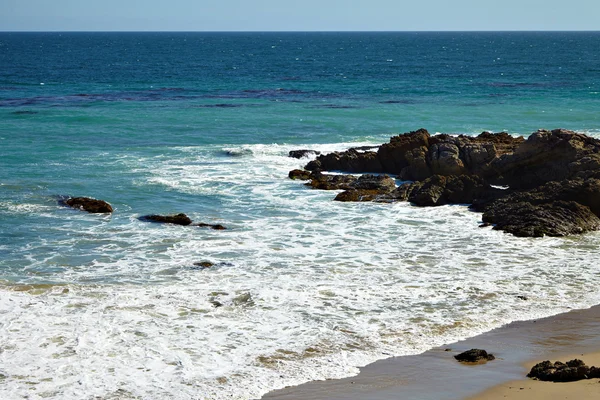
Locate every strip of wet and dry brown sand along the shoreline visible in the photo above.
<box><xmin>263</xmin><ymin>306</ymin><xmax>600</xmax><ymax>400</ymax></box>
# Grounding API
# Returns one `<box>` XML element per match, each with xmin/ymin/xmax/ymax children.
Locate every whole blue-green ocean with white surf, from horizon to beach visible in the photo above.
<box><xmin>0</xmin><ymin>32</ymin><xmax>600</xmax><ymax>400</ymax></box>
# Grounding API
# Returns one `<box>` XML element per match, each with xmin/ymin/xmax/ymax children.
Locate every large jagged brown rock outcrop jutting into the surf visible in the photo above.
<box><xmin>289</xmin><ymin>129</ymin><xmax>600</xmax><ymax>237</ymax></box>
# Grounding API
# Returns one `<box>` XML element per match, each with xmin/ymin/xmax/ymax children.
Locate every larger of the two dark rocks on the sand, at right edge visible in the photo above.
<box><xmin>527</xmin><ymin>359</ymin><xmax>600</xmax><ymax>382</ymax></box>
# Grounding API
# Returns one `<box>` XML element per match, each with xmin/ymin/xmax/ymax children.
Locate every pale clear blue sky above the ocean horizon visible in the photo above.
<box><xmin>0</xmin><ymin>0</ymin><xmax>600</xmax><ymax>31</ymax></box>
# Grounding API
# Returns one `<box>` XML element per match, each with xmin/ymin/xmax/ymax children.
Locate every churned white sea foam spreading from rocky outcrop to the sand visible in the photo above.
<box><xmin>0</xmin><ymin>143</ymin><xmax>600</xmax><ymax>399</ymax></box>
